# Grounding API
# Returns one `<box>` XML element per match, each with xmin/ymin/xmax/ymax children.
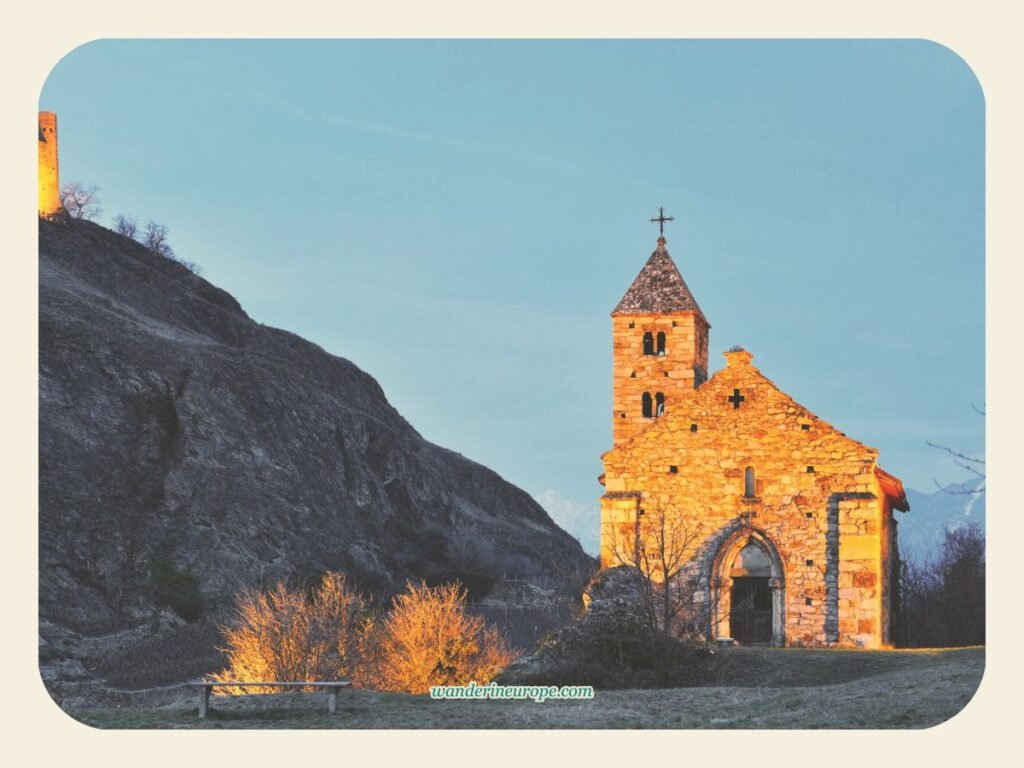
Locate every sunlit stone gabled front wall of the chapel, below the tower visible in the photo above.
<box><xmin>601</xmin><ymin>348</ymin><xmax>890</xmax><ymax>647</ymax></box>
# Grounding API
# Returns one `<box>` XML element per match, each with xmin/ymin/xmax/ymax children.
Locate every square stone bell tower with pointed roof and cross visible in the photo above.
<box><xmin>611</xmin><ymin>210</ymin><xmax>711</xmax><ymax>445</ymax></box>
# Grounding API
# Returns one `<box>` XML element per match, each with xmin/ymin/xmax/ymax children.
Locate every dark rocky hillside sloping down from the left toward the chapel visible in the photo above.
<box><xmin>39</xmin><ymin>221</ymin><xmax>592</xmax><ymax>704</ymax></box>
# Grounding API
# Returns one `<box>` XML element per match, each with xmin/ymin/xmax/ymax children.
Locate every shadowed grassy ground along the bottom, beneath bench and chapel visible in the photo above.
<box><xmin>68</xmin><ymin>648</ymin><xmax>985</xmax><ymax>729</ymax></box>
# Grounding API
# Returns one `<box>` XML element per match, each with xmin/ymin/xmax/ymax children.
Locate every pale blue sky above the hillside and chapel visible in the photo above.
<box><xmin>40</xmin><ymin>40</ymin><xmax>985</xmax><ymax>551</ymax></box>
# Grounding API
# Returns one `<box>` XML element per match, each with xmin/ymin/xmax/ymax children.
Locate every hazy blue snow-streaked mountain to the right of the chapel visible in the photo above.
<box><xmin>895</xmin><ymin>478</ymin><xmax>985</xmax><ymax>560</ymax></box>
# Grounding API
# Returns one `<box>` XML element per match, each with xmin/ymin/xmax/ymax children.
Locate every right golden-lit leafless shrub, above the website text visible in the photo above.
<box><xmin>361</xmin><ymin>583</ymin><xmax>515</xmax><ymax>693</ymax></box>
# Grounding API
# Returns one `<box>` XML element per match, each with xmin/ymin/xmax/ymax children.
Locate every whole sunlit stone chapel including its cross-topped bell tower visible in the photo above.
<box><xmin>599</xmin><ymin>224</ymin><xmax>909</xmax><ymax>648</ymax></box>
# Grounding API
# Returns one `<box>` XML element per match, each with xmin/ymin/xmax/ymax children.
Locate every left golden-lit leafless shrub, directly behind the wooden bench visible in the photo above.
<box><xmin>211</xmin><ymin>572</ymin><xmax>370</xmax><ymax>693</ymax></box>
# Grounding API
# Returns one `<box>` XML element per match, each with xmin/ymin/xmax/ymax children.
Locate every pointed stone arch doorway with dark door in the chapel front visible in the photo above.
<box><xmin>712</xmin><ymin>527</ymin><xmax>785</xmax><ymax>645</ymax></box>
